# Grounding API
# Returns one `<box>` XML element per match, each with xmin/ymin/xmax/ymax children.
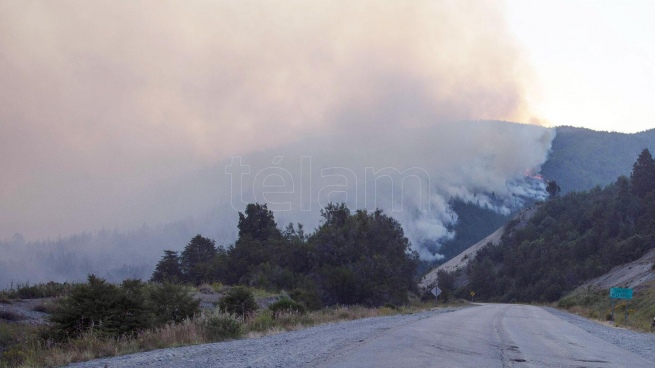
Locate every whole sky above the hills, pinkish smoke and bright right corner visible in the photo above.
<box><xmin>0</xmin><ymin>0</ymin><xmax>655</xmax><ymax>238</ymax></box>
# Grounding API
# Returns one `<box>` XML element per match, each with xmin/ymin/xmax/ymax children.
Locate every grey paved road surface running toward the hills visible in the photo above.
<box><xmin>318</xmin><ymin>304</ymin><xmax>655</xmax><ymax>368</ymax></box>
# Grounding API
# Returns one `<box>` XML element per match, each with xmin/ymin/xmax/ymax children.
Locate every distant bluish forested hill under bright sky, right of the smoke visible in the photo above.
<box><xmin>541</xmin><ymin>127</ymin><xmax>655</xmax><ymax>193</ymax></box>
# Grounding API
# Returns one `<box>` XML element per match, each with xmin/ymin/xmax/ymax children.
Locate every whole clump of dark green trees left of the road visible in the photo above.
<box><xmin>151</xmin><ymin>203</ymin><xmax>418</xmax><ymax>309</ymax></box>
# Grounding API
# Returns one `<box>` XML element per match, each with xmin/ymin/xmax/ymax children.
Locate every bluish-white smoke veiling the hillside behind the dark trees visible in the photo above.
<box><xmin>0</xmin><ymin>121</ymin><xmax>554</xmax><ymax>284</ymax></box>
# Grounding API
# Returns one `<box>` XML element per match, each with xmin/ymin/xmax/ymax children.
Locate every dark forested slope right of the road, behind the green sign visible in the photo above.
<box><xmin>459</xmin><ymin>149</ymin><xmax>655</xmax><ymax>302</ymax></box>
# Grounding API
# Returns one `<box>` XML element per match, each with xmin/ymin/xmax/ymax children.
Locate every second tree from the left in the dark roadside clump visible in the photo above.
<box><xmin>180</xmin><ymin>235</ymin><xmax>217</xmax><ymax>285</ymax></box>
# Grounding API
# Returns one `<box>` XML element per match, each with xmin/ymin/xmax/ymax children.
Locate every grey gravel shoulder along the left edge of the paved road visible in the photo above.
<box><xmin>69</xmin><ymin>307</ymin><xmax>466</xmax><ymax>368</ymax></box>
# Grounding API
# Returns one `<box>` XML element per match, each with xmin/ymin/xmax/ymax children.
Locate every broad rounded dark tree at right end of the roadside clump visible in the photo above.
<box><xmin>309</xmin><ymin>203</ymin><xmax>418</xmax><ymax>306</ymax></box>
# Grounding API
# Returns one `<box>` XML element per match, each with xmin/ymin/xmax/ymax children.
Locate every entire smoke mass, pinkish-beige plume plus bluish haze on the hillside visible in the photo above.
<box><xmin>0</xmin><ymin>0</ymin><xmax>552</xmax><ymax>286</ymax></box>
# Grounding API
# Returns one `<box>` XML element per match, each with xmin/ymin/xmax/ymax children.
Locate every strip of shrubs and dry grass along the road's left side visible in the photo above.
<box><xmin>0</xmin><ymin>277</ymin><xmax>461</xmax><ymax>367</ymax></box>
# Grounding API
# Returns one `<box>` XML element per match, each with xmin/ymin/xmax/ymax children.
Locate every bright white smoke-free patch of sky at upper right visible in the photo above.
<box><xmin>506</xmin><ymin>0</ymin><xmax>655</xmax><ymax>133</ymax></box>
